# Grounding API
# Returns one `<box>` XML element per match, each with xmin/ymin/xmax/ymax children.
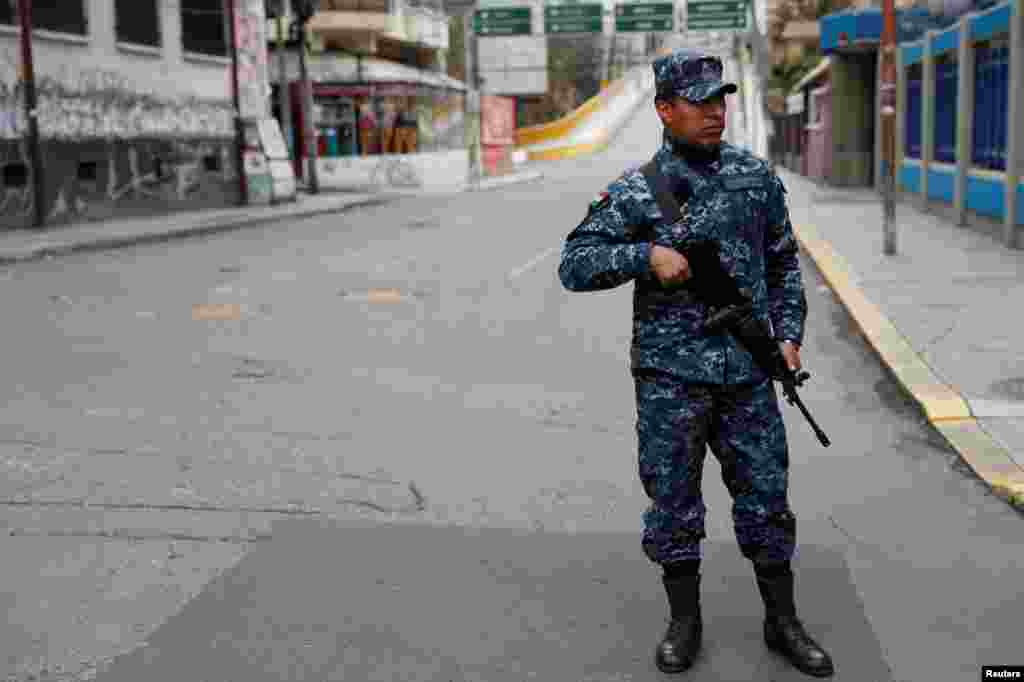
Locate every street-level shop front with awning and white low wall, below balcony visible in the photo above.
<box><xmin>284</xmin><ymin>58</ymin><xmax>469</xmax><ymax>190</ymax></box>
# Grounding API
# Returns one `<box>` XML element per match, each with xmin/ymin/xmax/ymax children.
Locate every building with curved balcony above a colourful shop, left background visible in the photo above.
<box><xmin>270</xmin><ymin>0</ymin><xmax>469</xmax><ymax>189</ymax></box>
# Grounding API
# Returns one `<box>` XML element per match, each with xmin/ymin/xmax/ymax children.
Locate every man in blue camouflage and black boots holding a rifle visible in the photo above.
<box><xmin>559</xmin><ymin>50</ymin><xmax>833</xmax><ymax>677</ymax></box>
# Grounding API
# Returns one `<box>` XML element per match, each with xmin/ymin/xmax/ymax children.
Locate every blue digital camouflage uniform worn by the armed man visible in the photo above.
<box><xmin>559</xmin><ymin>53</ymin><xmax>807</xmax><ymax>564</ymax></box>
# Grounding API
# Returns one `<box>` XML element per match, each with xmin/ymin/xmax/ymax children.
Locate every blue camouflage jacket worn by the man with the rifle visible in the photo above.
<box><xmin>558</xmin><ymin>140</ymin><xmax>807</xmax><ymax>385</ymax></box>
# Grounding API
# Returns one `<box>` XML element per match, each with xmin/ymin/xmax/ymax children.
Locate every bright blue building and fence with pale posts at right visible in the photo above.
<box><xmin>820</xmin><ymin>0</ymin><xmax>1024</xmax><ymax>248</ymax></box>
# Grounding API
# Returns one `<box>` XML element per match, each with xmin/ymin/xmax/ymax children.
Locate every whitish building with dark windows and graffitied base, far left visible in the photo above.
<box><xmin>0</xmin><ymin>0</ymin><xmax>238</xmax><ymax>228</ymax></box>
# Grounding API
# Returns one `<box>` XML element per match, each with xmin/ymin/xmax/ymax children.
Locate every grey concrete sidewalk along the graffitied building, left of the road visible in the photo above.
<box><xmin>0</xmin><ymin>169</ymin><xmax>543</xmax><ymax>265</ymax></box>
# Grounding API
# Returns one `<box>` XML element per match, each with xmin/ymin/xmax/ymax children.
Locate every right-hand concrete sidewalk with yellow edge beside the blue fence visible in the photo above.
<box><xmin>778</xmin><ymin>168</ymin><xmax>1024</xmax><ymax>508</ymax></box>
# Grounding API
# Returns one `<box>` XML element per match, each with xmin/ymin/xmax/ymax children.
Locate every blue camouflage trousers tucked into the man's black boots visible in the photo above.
<box><xmin>635</xmin><ymin>372</ymin><xmax>797</xmax><ymax>563</ymax></box>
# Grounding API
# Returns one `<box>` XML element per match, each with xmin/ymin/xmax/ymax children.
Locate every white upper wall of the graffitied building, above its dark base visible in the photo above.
<box><xmin>0</xmin><ymin>0</ymin><xmax>232</xmax><ymax>140</ymax></box>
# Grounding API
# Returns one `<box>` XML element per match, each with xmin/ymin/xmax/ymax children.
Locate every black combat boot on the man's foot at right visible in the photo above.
<box><xmin>755</xmin><ymin>565</ymin><xmax>835</xmax><ymax>677</ymax></box>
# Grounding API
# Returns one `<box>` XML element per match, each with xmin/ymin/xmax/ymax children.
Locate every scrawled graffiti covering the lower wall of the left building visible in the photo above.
<box><xmin>0</xmin><ymin>47</ymin><xmax>233</xmax><ymax>228</ymax></box>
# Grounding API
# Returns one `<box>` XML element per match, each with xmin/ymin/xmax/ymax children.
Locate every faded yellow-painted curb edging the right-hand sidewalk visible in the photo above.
<box><xmin>794</xmin><ymin>219</ymin><xmax>1024</xmax><ymax>511</ymax></box>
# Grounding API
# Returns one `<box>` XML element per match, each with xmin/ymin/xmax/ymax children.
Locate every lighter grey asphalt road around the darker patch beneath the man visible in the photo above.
<box><xmin>0</xmin><ymin>98</ymin><xmax>1024</xmax><ymax>682</ymax></box>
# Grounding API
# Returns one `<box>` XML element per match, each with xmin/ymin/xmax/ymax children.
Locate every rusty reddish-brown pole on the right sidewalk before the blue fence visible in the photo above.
<box><xmin>879</xmin><ymin>0</ymin><xmax>897</xmax><ymax>251</ymax></box>
